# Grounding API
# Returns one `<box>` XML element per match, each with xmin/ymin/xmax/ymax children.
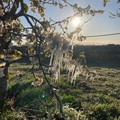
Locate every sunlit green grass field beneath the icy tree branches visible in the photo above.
<box><xmin>0</xmin><ymin>63</ymin><xmax>120</xmax><ymax>120</ymax></box>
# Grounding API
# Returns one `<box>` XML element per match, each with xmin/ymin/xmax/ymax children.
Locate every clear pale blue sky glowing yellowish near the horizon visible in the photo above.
<box><xmin>22</xmin><ymin>0</ymin><xmax>120</xmax><ymax>45</ymax></box>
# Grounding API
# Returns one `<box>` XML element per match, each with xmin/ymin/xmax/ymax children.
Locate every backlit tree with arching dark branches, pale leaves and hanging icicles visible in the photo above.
<box><xmin>0</xmin><ymin>0</ymin><xmax>113</xmax><ymax>116</ymax></box>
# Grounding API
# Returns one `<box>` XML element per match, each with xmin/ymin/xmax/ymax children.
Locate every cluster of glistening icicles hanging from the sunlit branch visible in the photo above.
<box><xmin>41</xmin><ymin>29</ymin><xmax>96</xmax><ymax>84</ymax></box>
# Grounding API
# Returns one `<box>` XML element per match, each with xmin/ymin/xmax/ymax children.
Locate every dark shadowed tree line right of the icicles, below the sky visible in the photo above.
<box><xmin>74</xmin><ymin>44</ymin><xmax>120</xmax><ymax>68</ymax></box>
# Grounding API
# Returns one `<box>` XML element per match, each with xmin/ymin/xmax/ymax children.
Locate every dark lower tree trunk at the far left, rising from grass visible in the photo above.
<box><xmin>0</xmin><ymin>65</ymin><xmax>8</xmax><ymax>110</ymax></box>
